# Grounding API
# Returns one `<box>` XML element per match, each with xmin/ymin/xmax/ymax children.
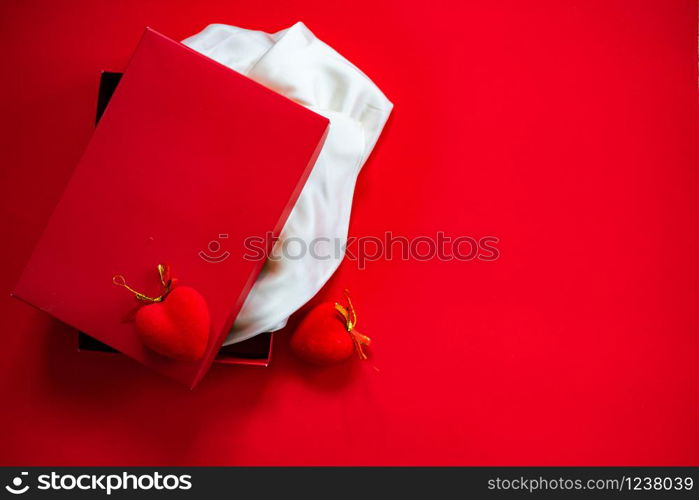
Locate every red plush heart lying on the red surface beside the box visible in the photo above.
<box><xmin>291</xmin><ymin>302</ymin><xmax>355</xmax><ymax>365</ymax></box>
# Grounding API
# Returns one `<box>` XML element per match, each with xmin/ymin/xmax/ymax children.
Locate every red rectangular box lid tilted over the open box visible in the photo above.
<box><xmin>14</xmin><ymin>29</ymin><xmax>328</xmax><ymax>387</ymax></box>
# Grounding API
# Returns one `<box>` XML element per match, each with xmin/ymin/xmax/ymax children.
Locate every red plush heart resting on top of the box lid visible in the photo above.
<box><xmin>136</xmin><ymin>286</ymin><xmax>210</xmax><ymax>361</ymax></box>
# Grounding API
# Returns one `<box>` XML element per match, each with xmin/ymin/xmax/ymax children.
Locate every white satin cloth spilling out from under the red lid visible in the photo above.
<box><xmin>182</xmin><ymin>23</ymin><xmax>393</xmax><ymax>345</ymax></box>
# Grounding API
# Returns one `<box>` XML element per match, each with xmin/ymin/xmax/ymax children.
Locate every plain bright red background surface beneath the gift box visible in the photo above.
<box><xmin>0</xmin><ymin>0</ymin><xmax>699</xmax><ymax>465</ymax></box>
